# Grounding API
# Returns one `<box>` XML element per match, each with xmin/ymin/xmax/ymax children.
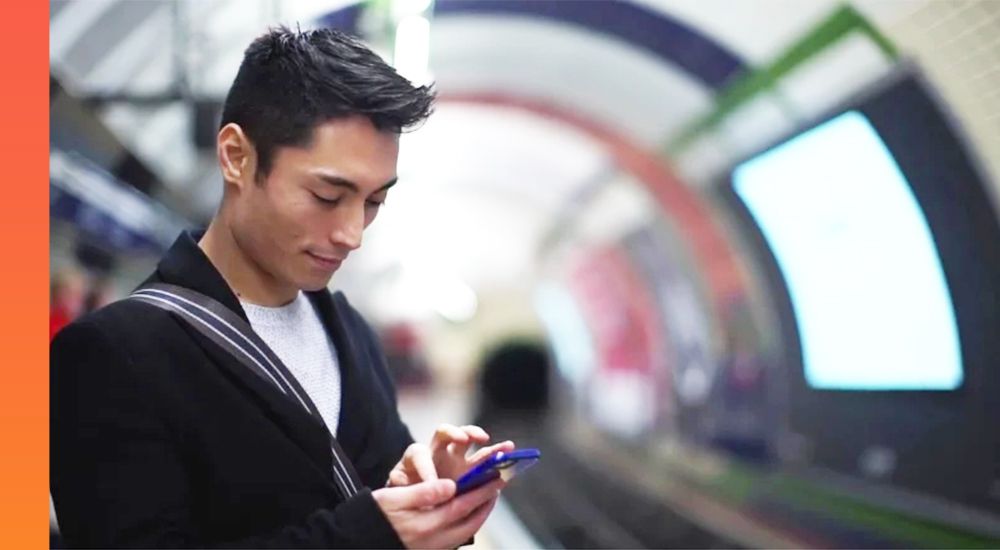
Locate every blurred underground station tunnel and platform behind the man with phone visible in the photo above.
<box><xmin>49</xmin><ymin>0</ymin><xmax>1000</xmax><ymax>548</ymax></box>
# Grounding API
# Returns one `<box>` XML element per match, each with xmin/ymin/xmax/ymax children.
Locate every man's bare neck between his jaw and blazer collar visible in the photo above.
<box><xmin>198</xmin><ymin>216</ymin><xmax>298</xmax><ymax>307</ymax></box>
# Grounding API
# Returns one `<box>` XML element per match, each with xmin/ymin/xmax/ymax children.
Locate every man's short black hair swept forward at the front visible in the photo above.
<box><xmin>220</xmin><ymin>26</ymin><xmax>435</xmax><ymax>177</ymax></box>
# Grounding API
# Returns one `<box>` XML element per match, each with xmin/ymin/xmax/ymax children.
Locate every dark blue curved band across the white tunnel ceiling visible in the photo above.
<box><xmin>320</xmin><ymin>0</ymin><xmax>746</xmax><ymax>90</ymax></box>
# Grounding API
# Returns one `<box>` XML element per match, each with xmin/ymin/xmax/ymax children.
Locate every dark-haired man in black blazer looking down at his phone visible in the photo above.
<box><xmin>51</xmin><ymin>24</ymin><xmax>513</xmax><ymax>548</ymax></box>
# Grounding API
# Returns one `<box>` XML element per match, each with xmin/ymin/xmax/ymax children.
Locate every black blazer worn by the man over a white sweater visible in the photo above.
<box><xmin>50</xmin><ymin>233</ymin><xmax>413</xmax><ymax>548</ymax></box>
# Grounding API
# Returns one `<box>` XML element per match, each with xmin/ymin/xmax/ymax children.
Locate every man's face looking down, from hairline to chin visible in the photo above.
<box><xmin>233</xmin><ymin>116</ymin><xmax>399</xmax><ymax>296</ymax></box>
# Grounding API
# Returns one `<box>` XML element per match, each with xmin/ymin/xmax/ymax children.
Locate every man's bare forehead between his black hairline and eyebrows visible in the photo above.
<box><xmin>273</xmin><ymin>115</ymin><xmax>399</xmax><ymax>189</ymax></box>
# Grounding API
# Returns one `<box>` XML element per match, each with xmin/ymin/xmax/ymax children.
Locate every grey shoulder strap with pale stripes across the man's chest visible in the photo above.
<box><xmin>129</xmin><ymin>283</ymin><xmax>362</xmax><ymax>500</ymax></box>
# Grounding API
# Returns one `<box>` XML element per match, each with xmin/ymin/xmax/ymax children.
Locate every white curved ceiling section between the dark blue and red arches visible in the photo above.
<box><xmin>431</xmin><ymin>15</ymin><xmax>712</xmax><ymax>147</ymax></box>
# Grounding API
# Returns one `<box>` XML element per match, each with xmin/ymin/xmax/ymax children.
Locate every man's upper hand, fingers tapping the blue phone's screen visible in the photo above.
<box><xmin>388</xmin><ymin>424</ymin><xmax>514</xmax><ymax>487</ymax></box>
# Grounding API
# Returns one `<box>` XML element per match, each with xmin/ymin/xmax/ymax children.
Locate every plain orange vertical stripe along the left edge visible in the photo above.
<box><xmin>0</xmin><ymin>0</ymin><xmax>49</xmax><ymax>548</ymax></box>
